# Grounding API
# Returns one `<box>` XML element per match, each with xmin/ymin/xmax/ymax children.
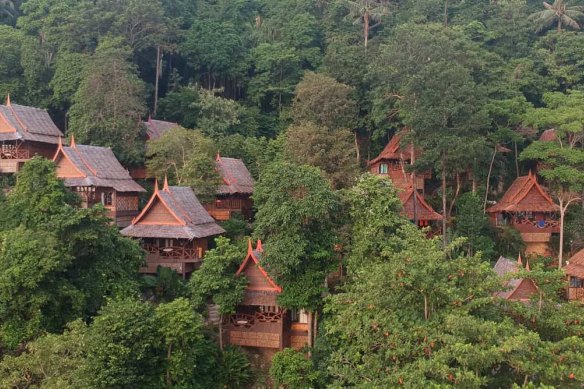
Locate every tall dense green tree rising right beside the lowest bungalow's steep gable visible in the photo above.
<box><xmin>253</xmin><ymin>162</ymin><xmax>339</xmax><ymax>309</ymax></box>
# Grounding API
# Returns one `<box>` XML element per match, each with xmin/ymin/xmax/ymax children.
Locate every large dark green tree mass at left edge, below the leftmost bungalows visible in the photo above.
<box><xmin>0</xmin><ymin>158</ymin><xmax>143</xmax><ymax>348</ymax></box>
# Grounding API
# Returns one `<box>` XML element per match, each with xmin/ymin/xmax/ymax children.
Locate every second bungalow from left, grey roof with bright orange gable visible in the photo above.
<box><xmin>53</xmin><ymin>137</ymin><xmax>145</xmax><ymax>227</ymax></box>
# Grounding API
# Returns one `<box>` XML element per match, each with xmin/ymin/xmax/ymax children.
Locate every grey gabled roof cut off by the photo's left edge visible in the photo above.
<box><xmin>0</xmin><ymin>96</ymin><xmax>63</xmax><ymax>144</ymax></box>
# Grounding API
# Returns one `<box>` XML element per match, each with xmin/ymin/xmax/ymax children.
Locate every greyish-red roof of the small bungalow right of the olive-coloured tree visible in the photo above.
<box><xmin>215</xmin><ymin>154</ymin><xmax>254</xmax><ymax>195</ymax></box>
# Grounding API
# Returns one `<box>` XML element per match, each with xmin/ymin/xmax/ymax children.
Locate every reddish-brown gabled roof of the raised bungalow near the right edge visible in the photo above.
<box><xmin>487</xmin><ymin>172</ymin><xmax>558</xmax><ymax>213</ymax></box>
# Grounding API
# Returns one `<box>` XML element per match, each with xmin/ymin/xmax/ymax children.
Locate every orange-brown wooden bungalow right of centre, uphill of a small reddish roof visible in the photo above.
<box><xmin>368</xmin><ymin>130</ymin><xmax>430</xmax><ymax>191</ymax></box>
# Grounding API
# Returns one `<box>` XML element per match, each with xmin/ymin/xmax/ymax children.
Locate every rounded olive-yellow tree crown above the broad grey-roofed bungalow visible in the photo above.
<box><xmin>146</xmin><ymin>128</ymin><xmax>219</xmax><ymax>201</ymax></box>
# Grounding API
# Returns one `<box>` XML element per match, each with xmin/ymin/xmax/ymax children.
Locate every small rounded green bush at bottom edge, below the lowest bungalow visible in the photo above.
<box><xmin>270</xmin><ymin>348</ymin><xmax>320</xmax><ymax>389</ymax></box>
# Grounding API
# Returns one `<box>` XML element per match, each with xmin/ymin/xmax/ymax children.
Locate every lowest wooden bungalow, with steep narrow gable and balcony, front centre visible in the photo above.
<box><xmin>222</xmin><ymin>241</ymin><xmax>311</xmax><ymax>351</ymax></box>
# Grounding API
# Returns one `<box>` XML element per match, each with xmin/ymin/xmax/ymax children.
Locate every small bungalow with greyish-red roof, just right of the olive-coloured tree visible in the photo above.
<box><xmin>205</xmin><ymin>154</ymin><xmax>254</xmax><ymax>221</ymax></box>
